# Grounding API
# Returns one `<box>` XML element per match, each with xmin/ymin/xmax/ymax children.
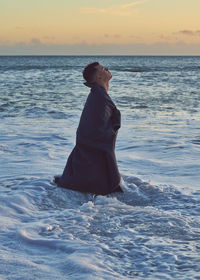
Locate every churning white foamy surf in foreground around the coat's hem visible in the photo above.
<box><xmin>0</xmin><ymin>176</ymin><xmax>200</xmax><ymax>279</ymax></box>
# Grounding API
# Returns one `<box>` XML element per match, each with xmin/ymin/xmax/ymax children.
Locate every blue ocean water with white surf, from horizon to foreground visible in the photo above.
<box><xmin>0</xmin><ymin>56</ymin><xmax>200</xmax><ymax>280</ymax></box>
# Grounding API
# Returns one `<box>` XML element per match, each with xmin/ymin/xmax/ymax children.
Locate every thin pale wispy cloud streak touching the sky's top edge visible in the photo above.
<box><xmin>80</xmin><ymin>0</ymin><xmax>149</xmax><ymax>16</ymax></box>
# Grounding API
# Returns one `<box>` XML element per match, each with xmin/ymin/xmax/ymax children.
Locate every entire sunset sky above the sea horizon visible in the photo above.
<box><xmin>0</xmin><ymin>0</ymin><xmax>200</xmax><ymax>55</ymax></box>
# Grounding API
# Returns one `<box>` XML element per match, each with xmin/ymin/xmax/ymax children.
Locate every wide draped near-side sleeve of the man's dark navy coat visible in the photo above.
<box><xmin>77</xmin><ymin>89</ymin><xmax>116</xmax><ymax>150</ymax></box>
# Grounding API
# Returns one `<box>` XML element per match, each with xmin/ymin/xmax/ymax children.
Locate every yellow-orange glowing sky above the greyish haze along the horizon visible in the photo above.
<box><xmin>0</xmin><ymin>0</ymin><xmax>200</xmax><ymax>54</ymax></box>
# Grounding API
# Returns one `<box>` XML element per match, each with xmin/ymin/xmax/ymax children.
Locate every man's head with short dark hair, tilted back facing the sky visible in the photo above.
<box><xmin>83</xmin><ymin>62</ymin><xmax>112</xmax><ymax>84</ymax></box>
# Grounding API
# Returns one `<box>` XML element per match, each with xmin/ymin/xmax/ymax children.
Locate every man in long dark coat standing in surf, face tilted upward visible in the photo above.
<box><xmin>55</xmin><ymin>62</ymin><xmax>123</xmax><ymax>195</ymax></box>
